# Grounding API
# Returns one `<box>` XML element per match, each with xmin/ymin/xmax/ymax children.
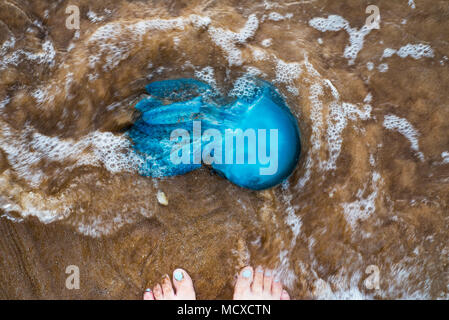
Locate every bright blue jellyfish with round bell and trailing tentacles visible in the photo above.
<box><xmin>128</xmin><ymin>78</ymin><xmax>301</xmax><ymax>190</ymax></box>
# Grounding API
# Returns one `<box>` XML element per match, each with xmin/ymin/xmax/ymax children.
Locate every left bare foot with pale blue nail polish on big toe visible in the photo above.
<box><xmin>143</xmin><ymin>269</ymin><xmax>195</xmax><ymax>300</ymax></box>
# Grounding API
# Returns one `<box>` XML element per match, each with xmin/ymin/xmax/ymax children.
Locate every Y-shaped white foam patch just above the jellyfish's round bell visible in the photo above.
<box><xmin>209</xmin><ymin>14</ymin><xmax>259</xmax><ymax>66</ymax></box>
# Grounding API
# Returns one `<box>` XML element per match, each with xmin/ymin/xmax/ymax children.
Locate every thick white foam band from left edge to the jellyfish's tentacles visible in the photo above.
<box><xmin>0</xmin><ymin>122</ymin><xmax>143</xmax><ymax>187</ymax></box>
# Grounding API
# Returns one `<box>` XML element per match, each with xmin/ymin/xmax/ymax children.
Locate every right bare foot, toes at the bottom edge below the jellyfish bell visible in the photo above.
<box><xmin>234</xmin><ymin>266</ymin><xmax>290</xmax><ymax>300</ymax></box>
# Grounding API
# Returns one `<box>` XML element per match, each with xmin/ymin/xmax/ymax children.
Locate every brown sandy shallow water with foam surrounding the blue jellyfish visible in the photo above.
<box><xmin>0</xmin><ymin>0</ymin><xmax>449</xmax><ymax>299</ymax></box>
